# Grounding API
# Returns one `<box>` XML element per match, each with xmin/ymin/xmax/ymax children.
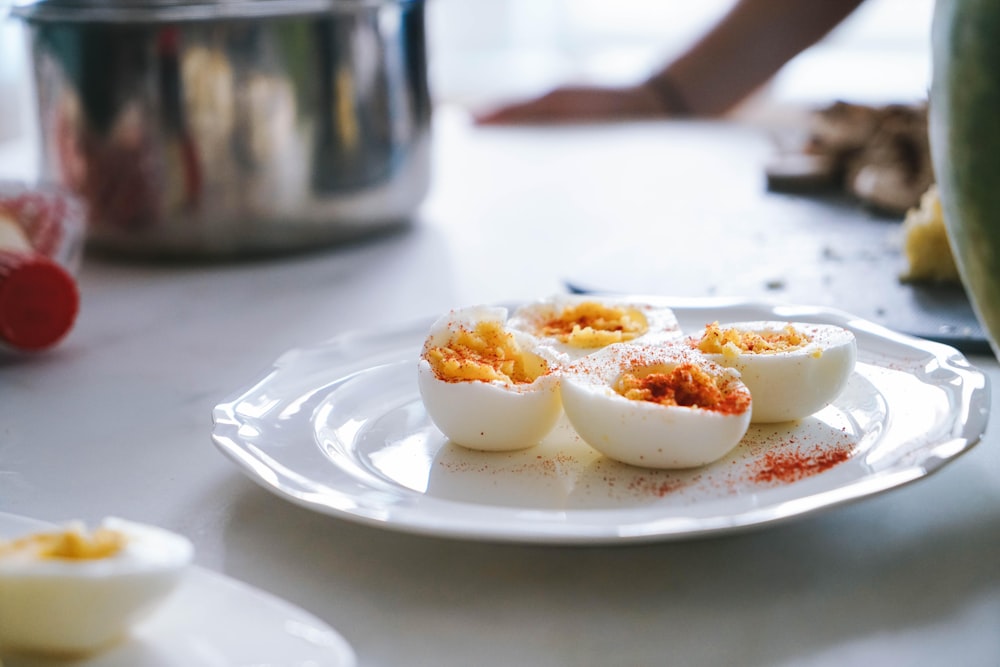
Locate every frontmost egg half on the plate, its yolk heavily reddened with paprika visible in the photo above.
<box><xmin>562</xmin><ymin>344</ymin><xmax>751</xmax><ymax>468</ymax></box>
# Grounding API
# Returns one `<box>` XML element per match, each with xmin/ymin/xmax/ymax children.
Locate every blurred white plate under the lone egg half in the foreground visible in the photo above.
<box><xmin>0</xmin><ymin>512</ymin><xmax>356</xmax><ymax>667</ymax></box>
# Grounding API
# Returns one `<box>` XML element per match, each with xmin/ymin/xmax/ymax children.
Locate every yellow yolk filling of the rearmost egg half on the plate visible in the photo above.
<box><xmin>539</xmin><ymin>301</ymin><xmax>649</xmax><ymax>348</ymax></box>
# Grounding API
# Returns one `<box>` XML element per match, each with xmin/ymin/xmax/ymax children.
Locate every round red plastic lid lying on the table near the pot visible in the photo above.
<box><xmin>0</xmin><ymin>251</ymin><xmax>80</xmax><ymax>350</ymax></box>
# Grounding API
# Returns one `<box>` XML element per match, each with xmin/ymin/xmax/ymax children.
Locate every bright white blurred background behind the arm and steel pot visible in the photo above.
<box><xmin>0</xmin><ymin>0</ymin><xmax>933</xmax><ymax>145</ymax></box>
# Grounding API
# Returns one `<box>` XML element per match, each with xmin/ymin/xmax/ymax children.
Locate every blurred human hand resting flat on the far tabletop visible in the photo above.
<box><xmin>476</xmin><ymin>85</ymin><xmax>669</xmax><ymax>125</ymax></box>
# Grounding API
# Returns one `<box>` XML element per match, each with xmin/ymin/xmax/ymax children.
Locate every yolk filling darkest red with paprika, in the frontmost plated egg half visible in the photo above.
<box><xmin>612</xmin><ymin>363</ymin><xmax>750</xmax><ymax>414</ymax></box>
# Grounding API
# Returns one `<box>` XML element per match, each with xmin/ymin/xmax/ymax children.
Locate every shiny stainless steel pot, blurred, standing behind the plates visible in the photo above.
<box><xmin>14</xmin><ymin>0</ymin><xmax>431</xmax><ymax>256</ymax></box>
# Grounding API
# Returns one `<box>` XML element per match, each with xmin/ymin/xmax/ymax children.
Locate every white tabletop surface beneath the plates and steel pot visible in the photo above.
<box><xmin>0</xmin><ymin>100</ymin><xmax>1000</xmax><ymax>667</ymax></box>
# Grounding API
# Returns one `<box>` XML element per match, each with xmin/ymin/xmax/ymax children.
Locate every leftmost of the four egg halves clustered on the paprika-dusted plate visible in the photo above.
<box><xmin>417</xmin><ymin>306</ymin><xmax>561</xmax><ymax>451</ymax></box>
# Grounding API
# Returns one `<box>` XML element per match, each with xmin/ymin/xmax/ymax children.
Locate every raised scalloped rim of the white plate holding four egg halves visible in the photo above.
<box><xmin>212</xmin><ymin>295</ymin><xmax>990</xmax><ymax>545</ymax></box>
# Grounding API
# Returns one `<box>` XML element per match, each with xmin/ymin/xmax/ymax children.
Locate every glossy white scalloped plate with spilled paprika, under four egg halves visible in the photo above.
<box><xmin>213</xmin><ymin>299</ymin><xmax>989</xmax><ymax>544</ymax></box>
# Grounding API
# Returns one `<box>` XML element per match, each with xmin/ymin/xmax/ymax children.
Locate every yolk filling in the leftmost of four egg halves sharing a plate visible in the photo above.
<box><xmin>424</xmin><ymin>321</ymin><xmax>549</xmax><ymax>384</ymax></box>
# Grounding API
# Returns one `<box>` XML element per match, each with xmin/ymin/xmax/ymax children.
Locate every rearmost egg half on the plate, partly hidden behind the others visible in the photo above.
<box><xmin>508</xmin><ymin>296</ymin><xmax>681</xmax><ymax>359</ymax></box>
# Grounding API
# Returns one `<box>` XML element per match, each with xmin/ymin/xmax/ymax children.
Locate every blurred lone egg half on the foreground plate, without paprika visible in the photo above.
<box><xmin>0</xmin><ymin>518</ymin><xmax>194</xmax><ymax>656</ymax></box>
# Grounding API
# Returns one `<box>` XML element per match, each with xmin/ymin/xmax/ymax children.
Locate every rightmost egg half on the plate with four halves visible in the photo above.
<box><xmin>689</xmin><ymin>321</ymin><xmax>857</xmax><ymax>423</ymax></box>
